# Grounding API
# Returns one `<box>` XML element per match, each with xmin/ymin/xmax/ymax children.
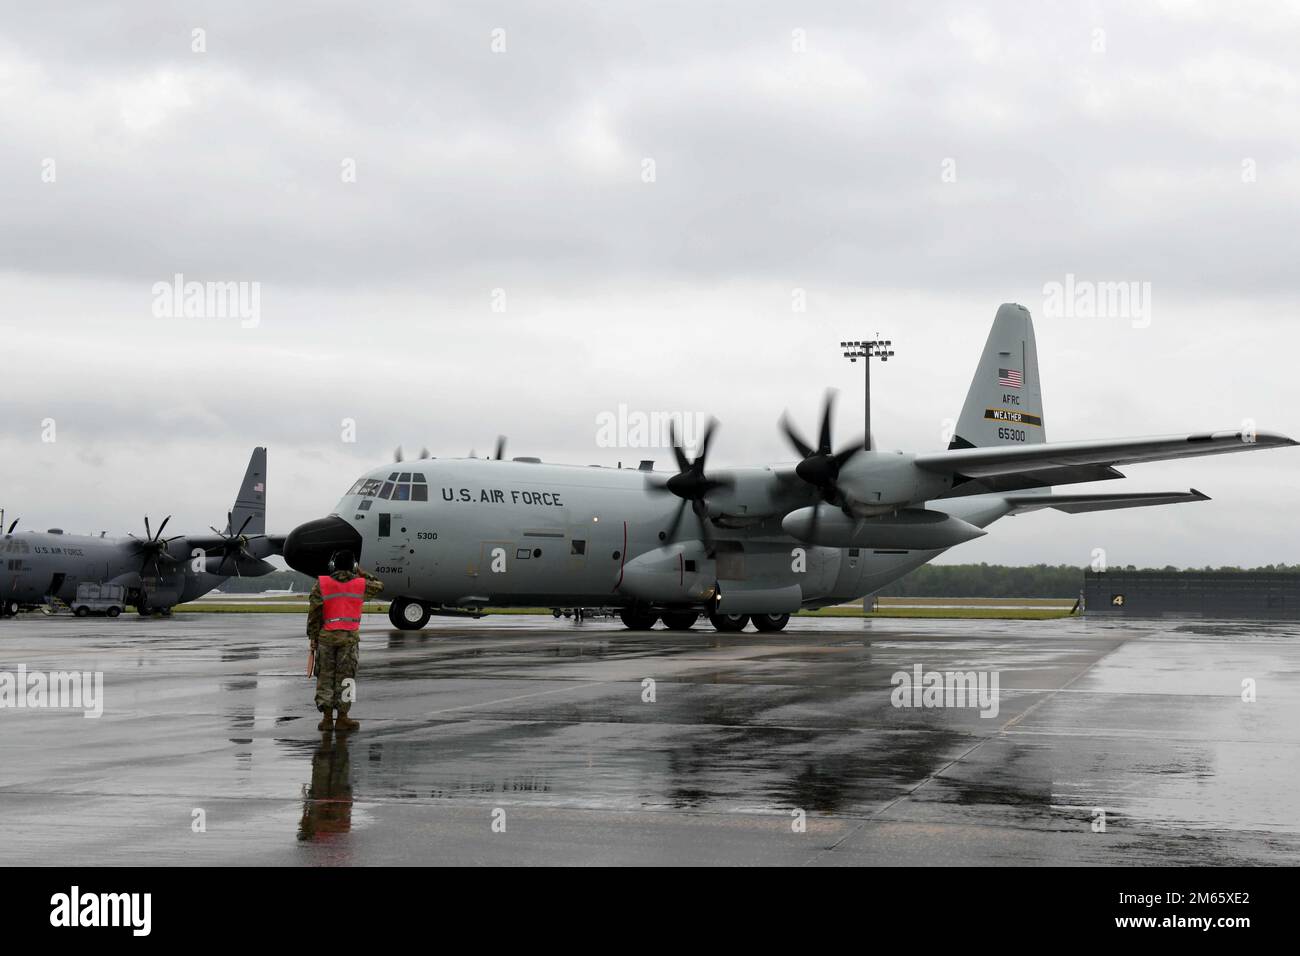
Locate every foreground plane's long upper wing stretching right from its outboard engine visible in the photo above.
<box><xmin>915</xmin><ymin>432</ymin><xmax>1300</xmax><ymax>479</ymax></box>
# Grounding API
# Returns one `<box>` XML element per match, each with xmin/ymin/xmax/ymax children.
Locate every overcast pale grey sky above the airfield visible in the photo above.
<box><xmin>0</xmin><ymin>0</ymin><xmax>1300</xmax><ymax>566</ymax></box>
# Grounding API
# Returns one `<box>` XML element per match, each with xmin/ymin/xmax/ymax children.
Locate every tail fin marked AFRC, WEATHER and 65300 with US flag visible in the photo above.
<box><xmin>948</xmin><ymin>302</ymin><xmax>1047</xmax><ymax>449</ymax></box>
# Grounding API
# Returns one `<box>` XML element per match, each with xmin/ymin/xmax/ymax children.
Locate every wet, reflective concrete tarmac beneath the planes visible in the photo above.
<box><xmin>0</xmin><ymin>614</ymin><xmax>1300</xmax><ymax>866</ymax></box>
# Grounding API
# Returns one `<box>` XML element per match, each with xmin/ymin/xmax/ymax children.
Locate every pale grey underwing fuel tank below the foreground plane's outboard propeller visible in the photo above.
<box><xmin>781</xmin><ymin>505</ymin><xmax>987</xmax><ymax>551</ymax></box>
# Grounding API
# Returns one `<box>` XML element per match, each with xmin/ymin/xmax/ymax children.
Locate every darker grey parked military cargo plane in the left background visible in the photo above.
<box><xmin>0</xmin><ymin>447</ymin><xmax>285</xmax><ymax>617</ymax></box>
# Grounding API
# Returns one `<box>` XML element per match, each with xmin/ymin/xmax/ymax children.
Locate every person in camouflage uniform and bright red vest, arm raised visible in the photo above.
<box><xmin>307</xmin><ymin>551</ymin><xmax>384</xmax><ymax>731</ymax></box>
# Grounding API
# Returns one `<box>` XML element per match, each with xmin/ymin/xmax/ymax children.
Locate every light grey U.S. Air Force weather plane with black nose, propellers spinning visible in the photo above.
<box><xmin>283</xmin><ymin>304</ymin><xmax>1296</xmax><ymax>631</ymax></box>
